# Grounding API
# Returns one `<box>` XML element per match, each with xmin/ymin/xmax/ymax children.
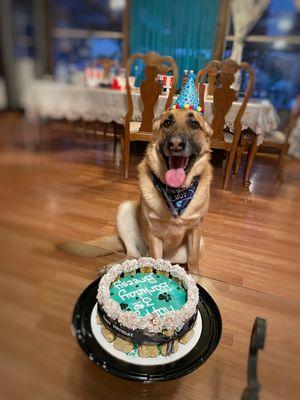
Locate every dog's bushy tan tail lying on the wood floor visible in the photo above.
<box><xmin>57</xmin><ymin>235</ymin><xmax>125</xmax><ymax>258</ymax></box>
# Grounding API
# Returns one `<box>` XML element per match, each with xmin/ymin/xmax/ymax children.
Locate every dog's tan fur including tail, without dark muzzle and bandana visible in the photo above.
<box><xmin>58</xmin><ymin>110</ymin><xmax>212</xmax><ymax>273</ymax></box>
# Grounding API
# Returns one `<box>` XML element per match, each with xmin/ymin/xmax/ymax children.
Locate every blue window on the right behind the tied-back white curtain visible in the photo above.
<box><xmin>224</xmin><ymin>0</ymin><xmax>300</xmax><ymax>110</ymax></box>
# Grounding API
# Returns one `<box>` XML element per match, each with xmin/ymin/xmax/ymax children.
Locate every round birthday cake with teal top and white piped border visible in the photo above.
<box><xmin>97</xmin><ymin>258</ymin><xmax>199</xmax><ymax>357</ymax></box>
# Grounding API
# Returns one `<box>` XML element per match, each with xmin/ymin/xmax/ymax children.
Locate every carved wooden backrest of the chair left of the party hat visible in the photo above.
<box><xmin>125</xmin><ymin>51</ymin><xmax>178</xmax><ymax>133</ymax></box>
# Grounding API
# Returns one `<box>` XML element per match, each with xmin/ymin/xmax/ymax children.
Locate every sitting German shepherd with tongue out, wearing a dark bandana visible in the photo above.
<box><xmin>60</xmin><ymin>109</ymin><xmax>212</xmax><ymax>273</ymax></box>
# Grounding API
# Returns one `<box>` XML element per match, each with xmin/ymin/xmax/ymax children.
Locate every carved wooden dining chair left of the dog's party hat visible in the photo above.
<box><xmin>121</xmin><ymin>51</ymin><xmax>178</xmax><ymax>178</ymax></box>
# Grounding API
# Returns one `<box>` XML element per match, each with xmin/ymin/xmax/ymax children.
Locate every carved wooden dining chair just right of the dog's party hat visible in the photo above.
<box><xmin>197</xmin><ymin>59</ymin><xmax>254</xmax><ymax>189</ymax></box>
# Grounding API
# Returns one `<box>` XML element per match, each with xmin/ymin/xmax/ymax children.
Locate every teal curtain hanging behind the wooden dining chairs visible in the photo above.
<box><xmin>130</xmin><ymin>0</ymin><xmax>219</xmax><ymax>80</ymax></box>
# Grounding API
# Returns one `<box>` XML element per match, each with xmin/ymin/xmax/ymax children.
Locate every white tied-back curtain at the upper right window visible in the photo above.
<box><xmin>231</xmin><ymin>0</ymin><xmax>270</xmax><ymax>63</ymax></box>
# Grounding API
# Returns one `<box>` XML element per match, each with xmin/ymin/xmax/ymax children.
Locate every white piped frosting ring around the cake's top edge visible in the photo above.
<box><xmin>97</xmin><ymin>257</ymin><xmax>199</xmax><ymax>333</ymax></box>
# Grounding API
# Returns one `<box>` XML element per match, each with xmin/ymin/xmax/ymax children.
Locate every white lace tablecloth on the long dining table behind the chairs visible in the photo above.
<box><xmin>24</xmin><ymin>80</ymin><xmax>279</xmax><ymax>145</ymax></box>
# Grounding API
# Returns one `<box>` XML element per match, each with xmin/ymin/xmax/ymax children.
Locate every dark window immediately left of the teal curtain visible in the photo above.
<box><xmin>51</xmin><ymin>0</ymin><xmax>125</xmax><ymax>69</ymax></box>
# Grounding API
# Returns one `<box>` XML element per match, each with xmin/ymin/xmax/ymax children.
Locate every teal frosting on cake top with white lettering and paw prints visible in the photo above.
<box><xmin>110</xmin><ymin>272</ymin><xmax>187</xmax><ymax>317</ymax></box>
